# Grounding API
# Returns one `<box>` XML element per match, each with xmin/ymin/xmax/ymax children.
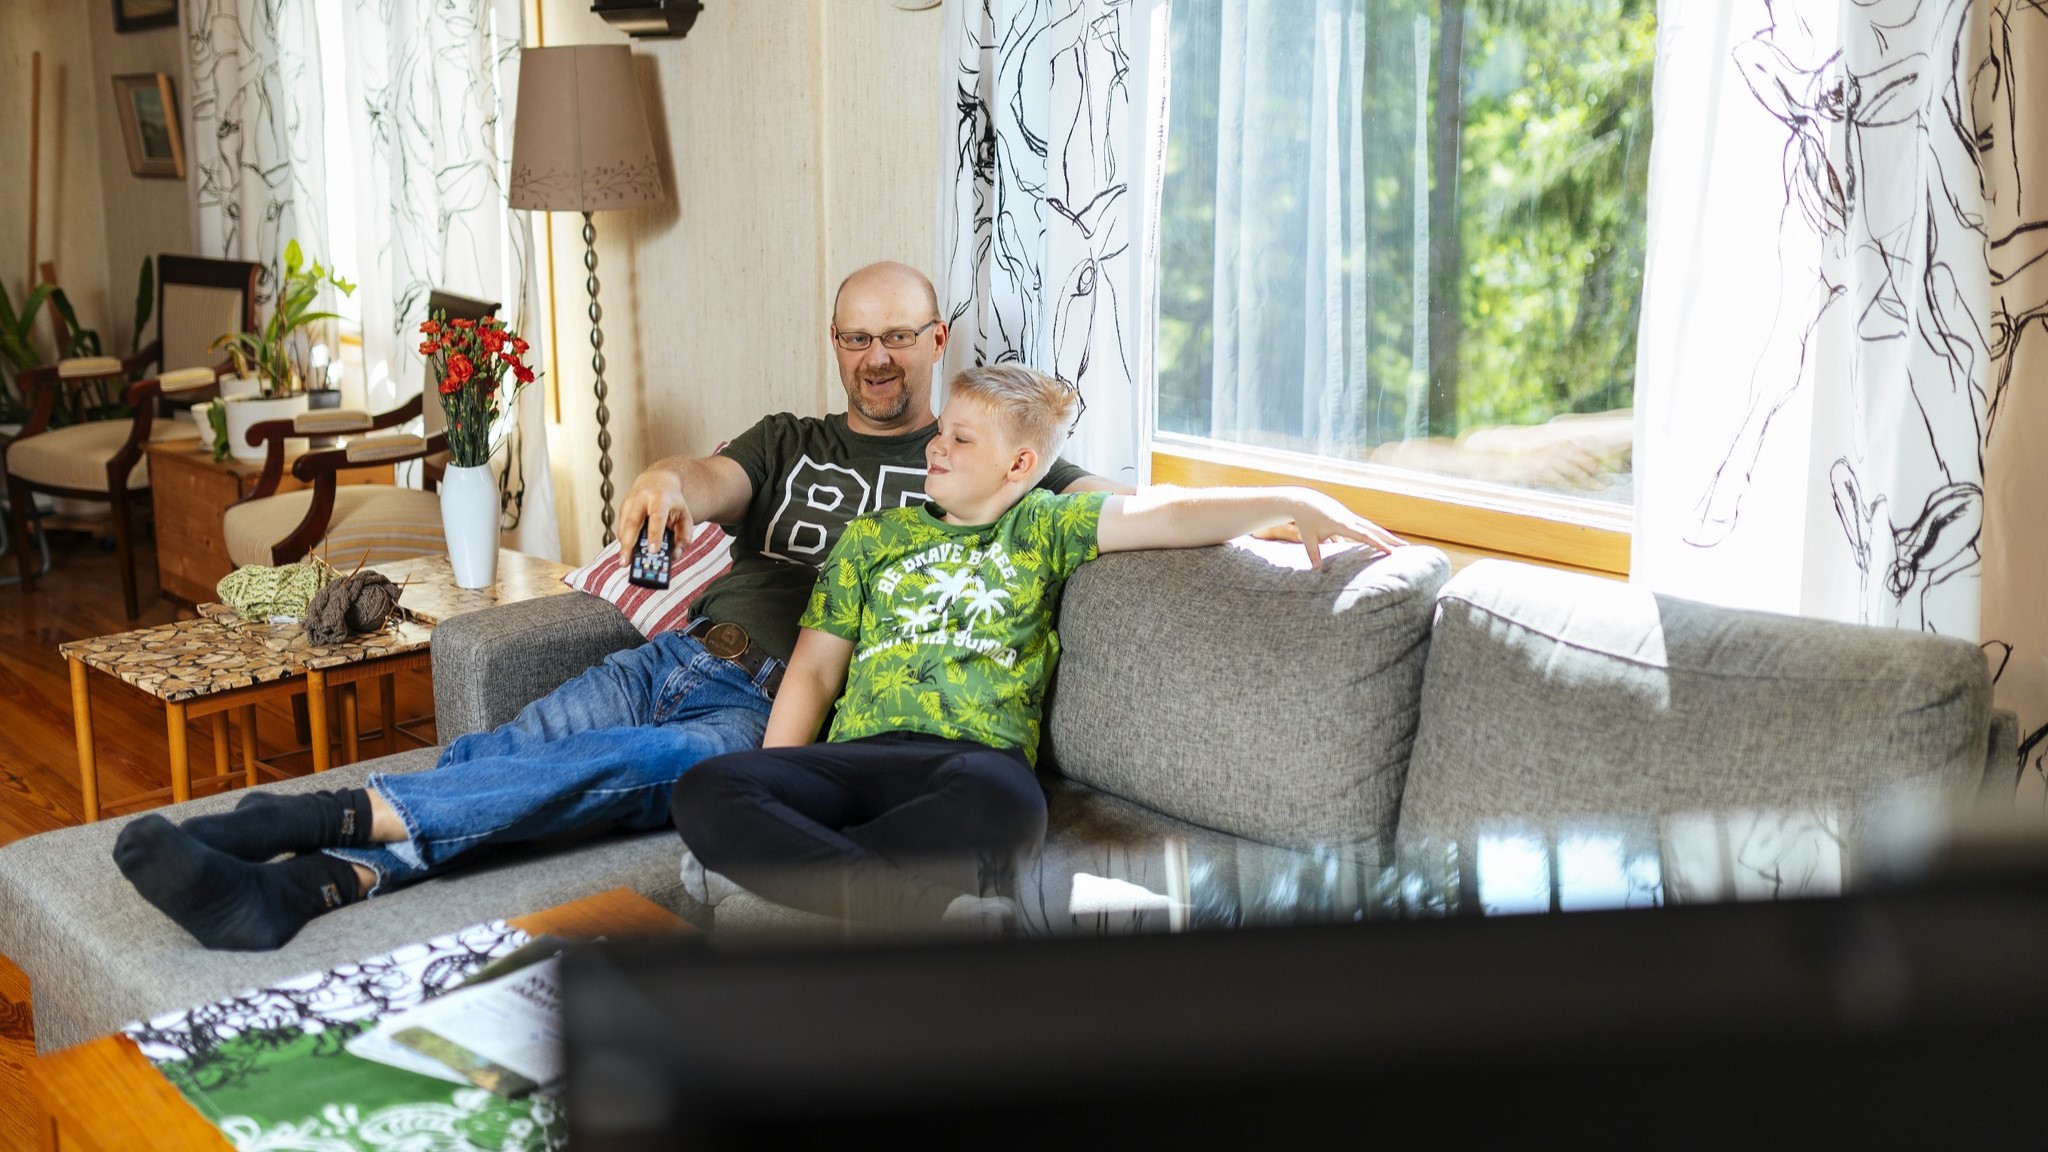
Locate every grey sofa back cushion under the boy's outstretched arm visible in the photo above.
<box><xmin>1047</xmin><ymin>541</ymin><xmax>1450</xmax><ymax>853</ymax></box>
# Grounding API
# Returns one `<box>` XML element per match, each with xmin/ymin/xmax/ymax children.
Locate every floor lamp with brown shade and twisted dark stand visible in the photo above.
<box><xmin>510</xmin><ymin>45</ymin><xmax>664</xmax><ymax>543</ymax></box>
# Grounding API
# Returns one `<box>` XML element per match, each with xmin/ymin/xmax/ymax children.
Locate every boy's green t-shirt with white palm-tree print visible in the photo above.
<box><xmin>801</xmin><ymin>488</ymin><xmax>1106</xmax><ymax>763</ymax></box>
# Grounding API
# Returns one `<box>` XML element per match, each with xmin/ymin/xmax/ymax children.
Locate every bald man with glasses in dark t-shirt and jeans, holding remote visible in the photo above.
<box><xmin>115</xmin><ymin>262</ymin><xmax>1128</xmax><ymax>951</ymax></box>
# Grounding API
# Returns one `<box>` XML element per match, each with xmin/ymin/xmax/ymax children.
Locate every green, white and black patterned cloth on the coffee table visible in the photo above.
<box><xmin>121</xmin><ymin>920</ymin><xmax>569</xmax><ymax>1152</ymax></box>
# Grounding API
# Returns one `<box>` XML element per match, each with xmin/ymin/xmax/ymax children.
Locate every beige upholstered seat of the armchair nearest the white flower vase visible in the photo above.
<box><xmin>221</xmin><ymin>484</ymin><xmax>449</xmax><ymax>572</ymax></box>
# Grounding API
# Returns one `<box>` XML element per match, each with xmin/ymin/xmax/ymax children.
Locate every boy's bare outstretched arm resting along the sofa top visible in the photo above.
<box><xmin>1096</xmin><ymin>488</ymin><xmax>1405</xmax><ymax>568</ymax></box>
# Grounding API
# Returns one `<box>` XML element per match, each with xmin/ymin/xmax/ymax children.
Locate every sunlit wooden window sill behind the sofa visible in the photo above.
<box><xmin>1151</xmin><ymin>433</ymin><xmax>1634</xmax><ymax>578</ymax></box>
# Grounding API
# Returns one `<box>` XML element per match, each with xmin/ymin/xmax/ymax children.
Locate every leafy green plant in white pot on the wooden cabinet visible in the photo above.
<box><xmin>213</xmin><ymin>240</ymin><xmax>356</xmax><ymax>461</ymax></box>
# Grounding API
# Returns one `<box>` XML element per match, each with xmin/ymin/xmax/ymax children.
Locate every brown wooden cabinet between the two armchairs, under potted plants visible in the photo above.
<box><xmin>150</xmin><ymin>441</ymin><xmax>393</xmax><ymax>605</ymax></box>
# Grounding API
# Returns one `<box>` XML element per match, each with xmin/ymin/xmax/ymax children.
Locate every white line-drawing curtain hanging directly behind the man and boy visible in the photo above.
<box><xmin>938</xmin><ymin>0</ymin><xmax>1165</xmax><ymax>484</ymax></box>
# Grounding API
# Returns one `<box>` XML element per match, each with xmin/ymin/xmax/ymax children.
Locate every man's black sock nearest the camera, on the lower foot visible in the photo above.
<box><xmin>115</xmin><ymin>816</ymin><xmax>360</xmax><ymax>951</ymax></box>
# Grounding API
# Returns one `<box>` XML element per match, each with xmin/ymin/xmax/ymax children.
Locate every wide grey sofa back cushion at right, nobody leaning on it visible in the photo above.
<box><xmin>1401</xmin><ymin>560</ymin><xmax>1991</xmax><ymax>842</ymax></box>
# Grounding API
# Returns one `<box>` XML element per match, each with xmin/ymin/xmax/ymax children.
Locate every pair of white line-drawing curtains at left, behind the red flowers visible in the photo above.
<box><xmin>184</xmin><ymin>0</ymin><xmax>561</xmax><ymax>558</ymax></box>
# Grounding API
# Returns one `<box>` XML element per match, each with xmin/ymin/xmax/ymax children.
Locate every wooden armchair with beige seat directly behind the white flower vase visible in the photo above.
<box><xmin>221</xmin><ymin>396</ymin><xmax>449</xmax><ymax>572</ymax></box>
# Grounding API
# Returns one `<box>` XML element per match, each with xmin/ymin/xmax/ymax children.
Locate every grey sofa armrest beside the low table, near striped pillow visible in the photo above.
<box><xmin>434</xmin><ymin>592</ymin><xmax>645</xmax><ymax>744</ymax></box>
